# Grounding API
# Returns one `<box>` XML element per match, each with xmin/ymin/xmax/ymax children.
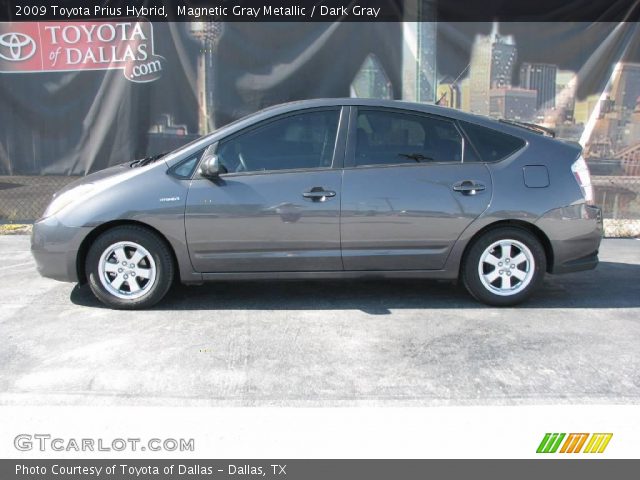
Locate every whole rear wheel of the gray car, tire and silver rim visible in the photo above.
<box><xmin>462</xmin><ymin>227</ymin><xmax>547</xmax><ymax>307</ymax></box>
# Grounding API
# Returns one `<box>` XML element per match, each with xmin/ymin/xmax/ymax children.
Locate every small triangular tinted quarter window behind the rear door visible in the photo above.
<box><xmin>460</xmin><ymin>122</ymin><xmax>525</xmax><ymax>162</ymax></box>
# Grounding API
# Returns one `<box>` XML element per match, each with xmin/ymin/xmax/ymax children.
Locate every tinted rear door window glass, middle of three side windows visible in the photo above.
<box><xmin>355</xmin><ymin>110</ymin><xmax>462</xmax><ymax>165</ymax></box>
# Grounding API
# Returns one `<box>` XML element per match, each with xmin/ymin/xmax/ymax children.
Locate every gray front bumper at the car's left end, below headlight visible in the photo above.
<box><xmin>31</xmin><ymin>216</ymin><xmax>91</xmax><ymax>282</ymax></box>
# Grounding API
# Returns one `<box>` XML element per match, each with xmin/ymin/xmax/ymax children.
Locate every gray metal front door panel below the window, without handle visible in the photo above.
<box><xmin>185</xmin><ymin>169</ymin><xmax>342</xmax><ymax>272</ymax></box>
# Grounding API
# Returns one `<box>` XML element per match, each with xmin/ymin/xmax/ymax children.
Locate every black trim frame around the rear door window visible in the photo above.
<box><xmin>344</xmin><ymin>105</ymin><xmax>470</xmax><ymax>169</ymax></box>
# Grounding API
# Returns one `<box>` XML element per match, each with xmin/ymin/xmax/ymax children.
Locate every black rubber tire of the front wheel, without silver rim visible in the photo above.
<box><xmin>85</xmin><ymin>225</ymin><xmax>174</xmax><ymax>309</ymax></box>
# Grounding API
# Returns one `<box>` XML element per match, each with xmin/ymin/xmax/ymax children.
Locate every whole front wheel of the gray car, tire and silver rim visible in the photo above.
<box><xmin>85</xmin><ymin>225</ymin><xmax>175</xmax><ymax>310</ymax></box>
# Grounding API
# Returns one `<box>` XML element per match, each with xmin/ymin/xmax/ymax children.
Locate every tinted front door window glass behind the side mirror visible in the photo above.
<box><xmin>217</xmin><ymin>110</ymin><xmax>340</xmax><ymax>173</ymax></box>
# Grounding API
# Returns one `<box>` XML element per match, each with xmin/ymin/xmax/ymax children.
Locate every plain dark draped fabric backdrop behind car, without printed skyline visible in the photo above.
<box><xmin>0</xmin><ymin>20</ymin><xmax>640</xmax><ymax>175</ymax></box>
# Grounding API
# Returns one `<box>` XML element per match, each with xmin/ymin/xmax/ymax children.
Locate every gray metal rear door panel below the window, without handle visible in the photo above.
<box><xmin>341</xmin><ymin>162</ymin><xmax>492</xmax><ymax>270</ymax></box>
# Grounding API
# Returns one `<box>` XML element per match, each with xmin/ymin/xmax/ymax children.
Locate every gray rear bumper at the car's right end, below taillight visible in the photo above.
<box><xmin>536</xmin><ymin>204</ymin><xmax>603</xmax><ymax>274</ymax></box>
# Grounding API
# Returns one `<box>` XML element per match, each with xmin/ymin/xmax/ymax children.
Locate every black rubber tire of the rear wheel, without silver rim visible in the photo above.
<box><xmin>462</xmin><ymin>227</ymin><xmax>547</xmax><ymax>306</ymax></box>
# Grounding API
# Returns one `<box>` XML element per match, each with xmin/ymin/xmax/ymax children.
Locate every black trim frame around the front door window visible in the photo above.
<box><xmin>196</xmin><ymin>105</ymin><xmax>348</xmax><ymax>178</ymax></box>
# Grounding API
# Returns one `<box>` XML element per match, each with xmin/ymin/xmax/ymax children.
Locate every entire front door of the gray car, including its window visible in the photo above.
<box><xmin>185</xmin><ymin>109</ymin><xmax>344</xmax><ymax>273</ymax></box>
